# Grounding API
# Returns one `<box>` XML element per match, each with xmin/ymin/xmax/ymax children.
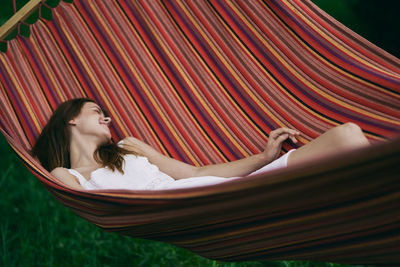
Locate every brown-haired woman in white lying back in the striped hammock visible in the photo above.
<box><xmin>32</xmin><ymin>98</ymin><xmax>369</xmax><ymax>190</ymax></box>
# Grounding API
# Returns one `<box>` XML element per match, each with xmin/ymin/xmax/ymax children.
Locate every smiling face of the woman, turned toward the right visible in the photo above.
<box><xmin>69</xmin><ymin>102</ymin><xmax>111</xmax><ymax>143</ymax></box>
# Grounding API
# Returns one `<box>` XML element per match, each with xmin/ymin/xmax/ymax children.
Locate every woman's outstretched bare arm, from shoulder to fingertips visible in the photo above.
<box><xmin>123</xmin><ymin>128</ymin><xmax>299</xmax><ymax>179</ymax></box>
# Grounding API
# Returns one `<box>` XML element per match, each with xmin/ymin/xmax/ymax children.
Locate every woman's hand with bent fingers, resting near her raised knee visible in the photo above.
<box><xmin>263</xmin><ymin>128</ymin><xmax>300</xmax><ymax>162</ymax></box>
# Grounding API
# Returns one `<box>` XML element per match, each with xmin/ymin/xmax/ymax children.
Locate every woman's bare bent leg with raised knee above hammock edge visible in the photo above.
<box><xmin>287</xmin><ymin>123</ymin><xmax>370</xmax><ymax>166</ymax></box>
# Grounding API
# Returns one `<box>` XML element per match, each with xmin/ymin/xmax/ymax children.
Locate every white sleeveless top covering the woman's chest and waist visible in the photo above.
<box><xmin>68</xmin><ymin>154</ymin><xmax>233</xmax><ymax>190</ymax></box>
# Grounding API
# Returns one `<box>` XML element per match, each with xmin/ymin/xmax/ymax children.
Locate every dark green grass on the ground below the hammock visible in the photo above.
<box><xmin>0</xmin><ymin>136</ymin><xmax>372</xmax><ymax>267</ymax></box>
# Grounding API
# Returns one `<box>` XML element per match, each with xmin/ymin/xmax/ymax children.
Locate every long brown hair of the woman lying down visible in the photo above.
<box><xmin>31</xmin><ymin>98</ymin><xmax>132</xmax><ymax>173</ymax></box>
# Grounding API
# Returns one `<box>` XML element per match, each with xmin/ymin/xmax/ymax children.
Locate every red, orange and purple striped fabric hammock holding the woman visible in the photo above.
<box><xmin>0</xmin><ymin>0</ymin><xmax>400</xmax><ymax>264</ymax></box>
